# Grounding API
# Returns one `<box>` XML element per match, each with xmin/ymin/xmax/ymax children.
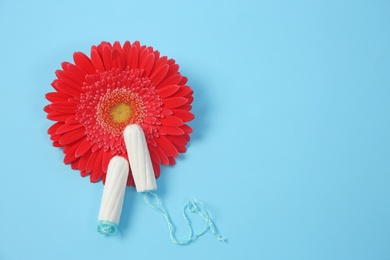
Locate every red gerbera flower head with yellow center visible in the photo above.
<box><xmin>44</xmin><ymin>41</ymin><xmax>194</xmax><ymax>186</ymax></box>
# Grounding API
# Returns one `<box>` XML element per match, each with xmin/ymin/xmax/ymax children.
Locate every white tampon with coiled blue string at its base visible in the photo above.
<box><xmin>98</xmin><ymin>156</ymin><xmax>129</xmax><ymax>235</ymax></box>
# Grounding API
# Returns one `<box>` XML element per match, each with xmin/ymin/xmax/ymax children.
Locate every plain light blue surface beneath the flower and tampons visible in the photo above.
<box><xmin>0</xmin><ymin>0</ymin><xmax>390</xmax><ymax>260</ymax></box>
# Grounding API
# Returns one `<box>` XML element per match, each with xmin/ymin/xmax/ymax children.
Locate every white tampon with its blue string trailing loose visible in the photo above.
<box><xmin>123</xmin><ymin>124</ymin><xmax>157</xmax><ymax>192</ymax></box>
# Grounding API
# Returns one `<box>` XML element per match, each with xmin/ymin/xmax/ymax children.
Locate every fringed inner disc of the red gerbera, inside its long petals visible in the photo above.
<box><xmin>76</xmin><ymin>67</ymin><xmax>162</xmax><ymax>155</ymax></box>
